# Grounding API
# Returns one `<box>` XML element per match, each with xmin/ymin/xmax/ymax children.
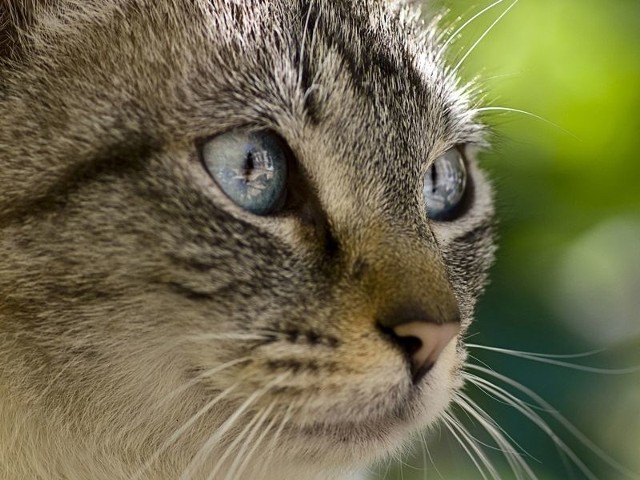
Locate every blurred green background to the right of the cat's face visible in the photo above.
<box><xmin>379</xmin><ymin>0</ymin><xmax>640</xmax><ymax>480</ymax></box>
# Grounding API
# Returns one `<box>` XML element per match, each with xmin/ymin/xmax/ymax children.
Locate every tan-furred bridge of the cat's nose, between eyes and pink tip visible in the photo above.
<box><xmin>314</xmin><ymin>147</ymin><xmax>460</xmax><ymax>322</ymax></box>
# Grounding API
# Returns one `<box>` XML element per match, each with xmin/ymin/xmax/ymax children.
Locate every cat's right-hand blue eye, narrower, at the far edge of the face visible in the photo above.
<box><xmin>424</xmin><ymin>148</ymin><xmax>467</xmax><ymax>221</ymax></box>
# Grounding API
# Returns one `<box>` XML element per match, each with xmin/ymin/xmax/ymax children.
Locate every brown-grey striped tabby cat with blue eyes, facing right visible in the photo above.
<box><xmin>0</xmin><ymin>0</ymin><xmax>495</xmax><ymax>480</ymax></box>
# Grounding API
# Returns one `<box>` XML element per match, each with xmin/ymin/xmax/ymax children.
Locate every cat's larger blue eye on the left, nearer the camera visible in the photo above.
<box><xmin>201</xmin><ymin>131</ymin><xmax>288</xmax><ymax>215</ymax></box>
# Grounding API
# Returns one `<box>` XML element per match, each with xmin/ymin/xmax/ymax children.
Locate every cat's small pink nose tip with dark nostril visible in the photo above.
<box><xmin>393</xmin><ymin>322</ymin><xmax>460</xmax><ymax>383</ymax></box>
